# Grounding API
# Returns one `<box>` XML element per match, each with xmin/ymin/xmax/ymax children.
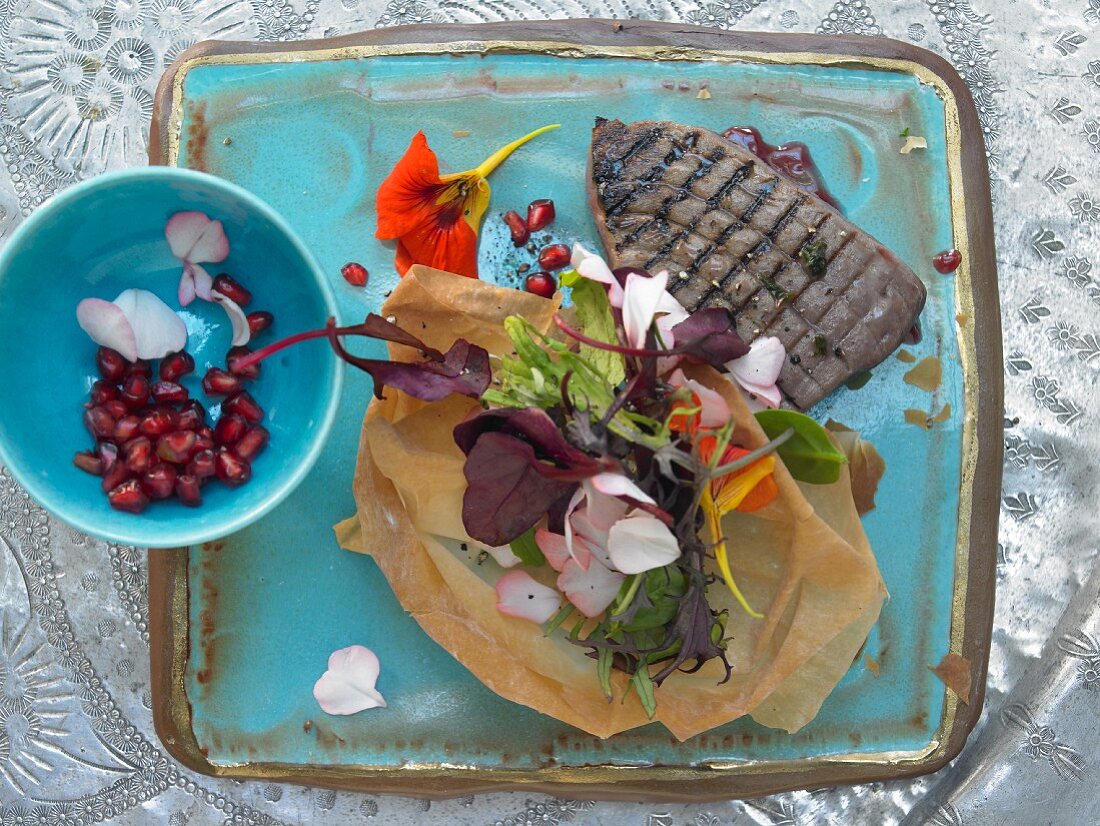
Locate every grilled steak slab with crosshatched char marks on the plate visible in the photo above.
<box><xmin>590</xmin><ymin>119</ymin><xmax>925</xmax><ymax>409</ymax></box>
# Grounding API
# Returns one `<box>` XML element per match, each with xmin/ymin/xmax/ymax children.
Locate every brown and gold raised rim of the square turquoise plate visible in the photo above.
<box><xmin>149</xmin><ymin>20</ymin><xmax>1003</xmax><ymax>801</ymax></box>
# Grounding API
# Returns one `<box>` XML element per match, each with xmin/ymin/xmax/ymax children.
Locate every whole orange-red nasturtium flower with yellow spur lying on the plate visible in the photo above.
<box><xmin>374</xmin><ymin>123</ymin><xmax>559</xmax><ymax>278</ymax></box>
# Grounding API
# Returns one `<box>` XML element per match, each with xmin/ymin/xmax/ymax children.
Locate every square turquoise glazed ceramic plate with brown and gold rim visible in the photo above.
<box><xmin>150</xmin><ymin>21</ymin><xmax>1001</xmax><ymax>799</ymax></box>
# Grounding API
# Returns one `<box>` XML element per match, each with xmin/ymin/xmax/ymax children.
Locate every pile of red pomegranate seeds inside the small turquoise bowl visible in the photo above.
<box><xmin>73</xmin><ymin>274</ymin><xmax>275</xmax><ymax>514</ymax></box>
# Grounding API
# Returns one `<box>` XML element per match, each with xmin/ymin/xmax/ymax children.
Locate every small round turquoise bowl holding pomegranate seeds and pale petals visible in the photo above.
<box><xmin>0</xmin><ymin>167</ymin><xmax>343</xmax><ymax>548</ymax></box>
